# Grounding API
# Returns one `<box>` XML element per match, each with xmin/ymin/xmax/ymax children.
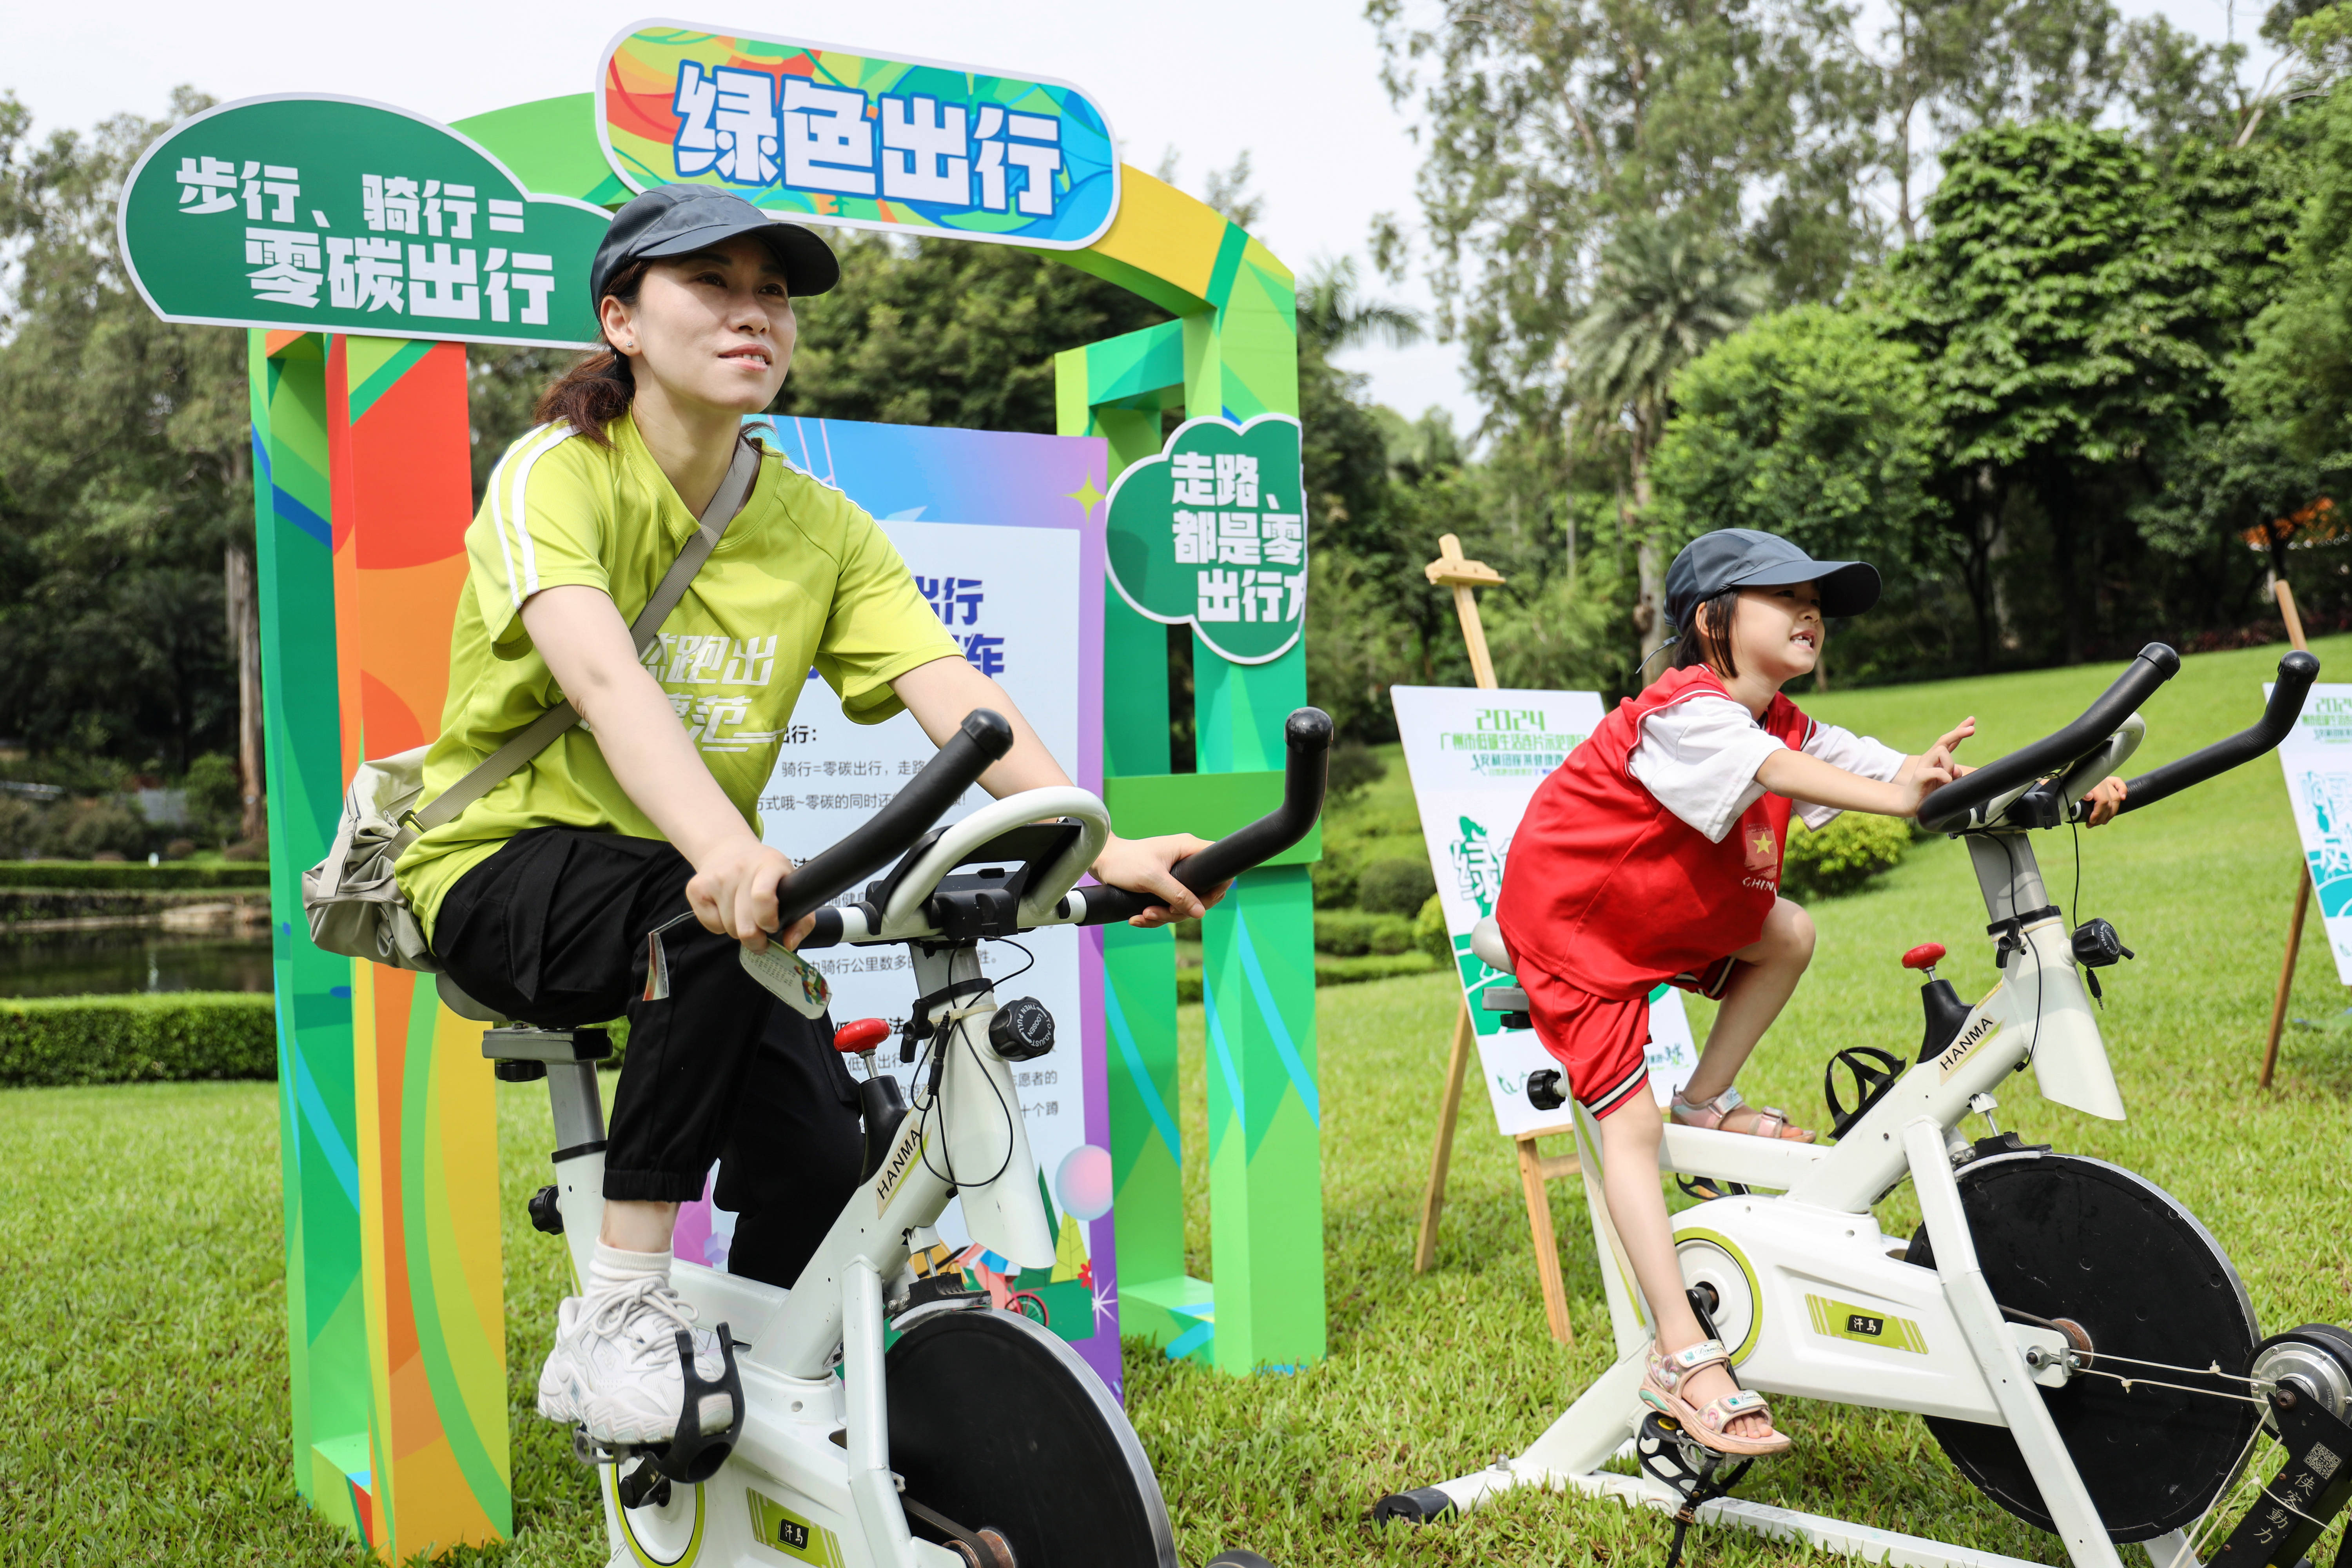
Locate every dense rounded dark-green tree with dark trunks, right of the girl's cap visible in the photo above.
<box><xmin>1889</xmin><ymin>120</ymin><xmax>2220</xmax><ymax>668</ymax></box>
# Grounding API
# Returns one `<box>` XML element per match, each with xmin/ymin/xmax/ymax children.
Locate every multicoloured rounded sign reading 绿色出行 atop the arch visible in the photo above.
<box><xmin>597</xmin><ymin>24</ymin><xmax>1120</xmax><ymax>252</ymax></box>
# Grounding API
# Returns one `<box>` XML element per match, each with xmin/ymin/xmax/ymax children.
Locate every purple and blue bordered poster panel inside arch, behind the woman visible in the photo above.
<box><xmin>677</xmin><ymin>418</ymin><xmax>1120</xmax><ymax>1389</ymax></box>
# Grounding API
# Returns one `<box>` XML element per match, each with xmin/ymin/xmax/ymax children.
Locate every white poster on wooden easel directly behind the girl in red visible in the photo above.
<box><xmin>1388</xmin><ymin>686</ymin><xmax>1698</xmax><ymax>1138</ymax></box>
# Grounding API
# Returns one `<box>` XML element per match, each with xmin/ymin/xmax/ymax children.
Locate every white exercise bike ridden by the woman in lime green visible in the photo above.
<box><xmin>482</xmin><ymin>708</ymin><xmax>1331</xmax><ymax>1568</ymax></box>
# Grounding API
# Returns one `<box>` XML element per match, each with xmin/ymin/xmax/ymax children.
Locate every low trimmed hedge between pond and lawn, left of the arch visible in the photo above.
<box><xmin>0</xmin><ymin>992</ymin><xmax>278</xmax><ymax>1089</ymax></box>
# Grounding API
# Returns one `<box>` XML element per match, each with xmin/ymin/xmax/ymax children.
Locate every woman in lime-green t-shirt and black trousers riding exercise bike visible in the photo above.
<box><xmin>397</xmin><ymin>186</ymin><xmax>1202</xmax><ymax>1443</ymax></box>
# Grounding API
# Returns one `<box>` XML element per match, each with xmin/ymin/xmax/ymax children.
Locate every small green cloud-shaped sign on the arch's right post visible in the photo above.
<box><xmin>1108</xmin><ymin>414</ymin><xmax>1308</xmax><ymax>665</ymax></box>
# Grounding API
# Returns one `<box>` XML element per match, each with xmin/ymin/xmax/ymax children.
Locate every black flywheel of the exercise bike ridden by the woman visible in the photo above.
<box><xmin>884</xmin><ymin>1309</ymin><xmax>1178</xmax><ymax>1568</ymax></box>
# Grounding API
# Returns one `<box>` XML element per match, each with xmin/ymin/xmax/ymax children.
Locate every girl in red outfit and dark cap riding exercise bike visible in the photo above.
<box><xmin>1496</xmin><ymin>529</ymin><xmax>2124</xmax><ymax>1455</ymax></box>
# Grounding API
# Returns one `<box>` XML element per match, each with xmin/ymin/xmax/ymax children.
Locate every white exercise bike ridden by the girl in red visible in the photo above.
<box><xmin>1376</xmin><ymin>644</ymin><xmax>2352</xmax><ymax>1568</ymax></box>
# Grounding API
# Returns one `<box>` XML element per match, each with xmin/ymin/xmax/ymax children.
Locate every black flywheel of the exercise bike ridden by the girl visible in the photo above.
<box><xmin>1905</xmin><ymin>1150</ymin><xmax>2263</xmax><ymax>1542</ymax></box>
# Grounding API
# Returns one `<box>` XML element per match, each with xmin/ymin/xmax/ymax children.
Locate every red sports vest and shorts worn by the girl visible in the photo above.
<box><xmin>1494</xmin><ymin>665</ymin><xmax>1813</xmax><ymax>1117</ymax></box>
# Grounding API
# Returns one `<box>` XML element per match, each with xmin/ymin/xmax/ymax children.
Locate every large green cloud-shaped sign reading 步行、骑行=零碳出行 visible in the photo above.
<box><xmin>115</xmin><ymin>96</ymin><xmax>609</xmax><ymax>346</ymax></box>
